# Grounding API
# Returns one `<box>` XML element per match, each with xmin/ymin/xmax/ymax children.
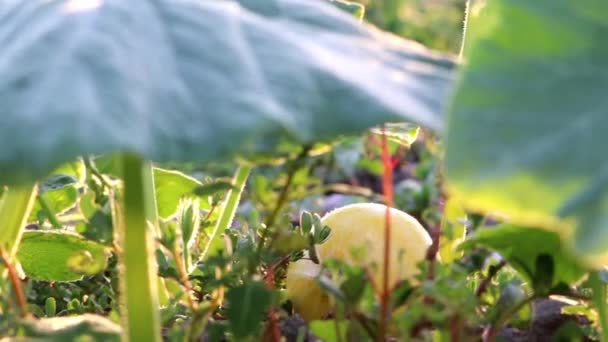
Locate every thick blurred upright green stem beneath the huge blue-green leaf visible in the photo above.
<box><xmin>114</xmin><ymin>154</ymin><xmax>161</xmax><ymax>342</ymax></box>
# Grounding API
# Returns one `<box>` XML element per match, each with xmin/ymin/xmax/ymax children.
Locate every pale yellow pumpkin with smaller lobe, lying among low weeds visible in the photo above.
<box><xmin>286</xmin><ymin>203</ymin><xmax>432</xmax><ymax>320</ymax></box>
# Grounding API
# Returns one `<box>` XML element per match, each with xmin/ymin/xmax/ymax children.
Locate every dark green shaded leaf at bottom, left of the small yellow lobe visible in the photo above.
<box><xmin>226</xmin><ymin>282</ymin><xmax>272</xmax><ymax>338</ymax></box>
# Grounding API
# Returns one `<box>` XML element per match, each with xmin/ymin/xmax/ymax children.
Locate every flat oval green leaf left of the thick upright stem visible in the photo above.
<box><xmin>17</xmin><ymin>231</ymin><xmax>108</xmax><ymax>281</ymax></box>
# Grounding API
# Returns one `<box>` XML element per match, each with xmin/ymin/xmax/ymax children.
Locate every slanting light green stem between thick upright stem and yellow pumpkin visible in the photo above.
<box><xmin>200</xmin><ymin>165</ymin><xmax>252</xmax><ymax>260</ymax></box>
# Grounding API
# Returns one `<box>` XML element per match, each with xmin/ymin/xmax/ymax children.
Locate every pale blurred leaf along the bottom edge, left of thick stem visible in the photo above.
<box><xmin>16</xmin><ymin>314</ymin><xmax>121</xmax><ymax>342</ymax></box>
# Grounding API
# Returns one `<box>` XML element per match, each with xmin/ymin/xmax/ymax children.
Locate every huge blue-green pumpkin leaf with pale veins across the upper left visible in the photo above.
<box><xmin>0</xmin><ymin>0</ymin><xmax>453</xmax><ymax>183</ymax></box>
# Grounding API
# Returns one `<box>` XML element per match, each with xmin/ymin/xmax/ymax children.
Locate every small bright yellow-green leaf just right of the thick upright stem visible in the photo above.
<box><xmin>154</xmin><ymin>168</ymin><xmax>201</xmax><ymax>218</ymax></box>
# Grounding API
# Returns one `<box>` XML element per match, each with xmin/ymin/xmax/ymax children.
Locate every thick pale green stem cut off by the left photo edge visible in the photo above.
<box><xmin>0</xmin><ymin>185</ymin><xmax>36</xmax><ymax>258</ymax></box>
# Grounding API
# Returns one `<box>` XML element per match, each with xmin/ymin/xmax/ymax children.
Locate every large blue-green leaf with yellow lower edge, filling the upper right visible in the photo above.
<box><xmin>446</xmin><ymin>0</ymin><xmax>608</xmax><ymax>265</ymax></box>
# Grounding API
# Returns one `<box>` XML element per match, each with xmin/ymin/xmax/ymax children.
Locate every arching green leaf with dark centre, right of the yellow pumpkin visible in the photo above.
<box><xmin>461</xmin><ymin>225</ymin><xmax>586</xmax><ymax>288</ymax></box>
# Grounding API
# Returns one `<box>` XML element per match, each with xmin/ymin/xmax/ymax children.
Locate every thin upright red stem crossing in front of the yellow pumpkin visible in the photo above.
<box><xmin>378</xmin><ymin>125</ymin><xmax>393</xmax><ymax>341</ymax></box>
